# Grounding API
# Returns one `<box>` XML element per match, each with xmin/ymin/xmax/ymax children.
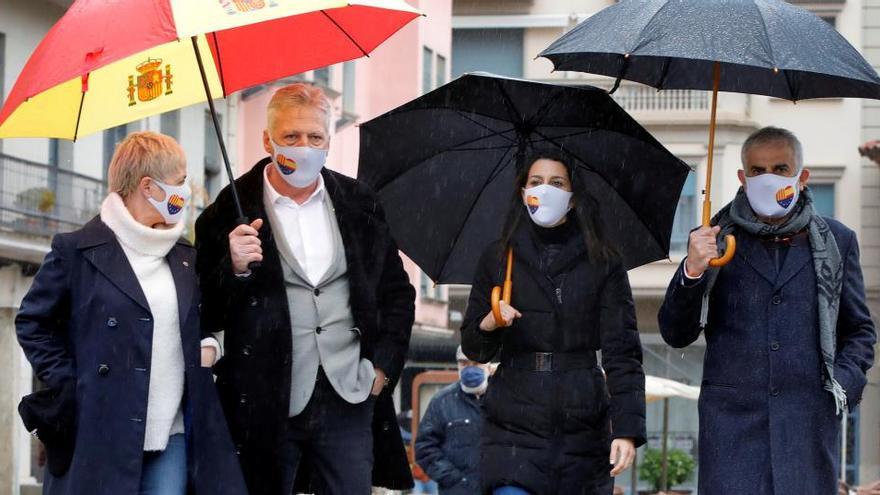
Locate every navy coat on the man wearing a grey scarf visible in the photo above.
<box><xmin>659</xmin><ymin>219</ymin><xmax>876</xmax><ymax>495</ymax></box>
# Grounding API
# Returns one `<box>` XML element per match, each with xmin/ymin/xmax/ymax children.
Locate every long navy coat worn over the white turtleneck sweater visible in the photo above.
<box><xmin>15</xmin><ymin>218</ymin><xmax>246</xmax><ymax>495</ymax></box>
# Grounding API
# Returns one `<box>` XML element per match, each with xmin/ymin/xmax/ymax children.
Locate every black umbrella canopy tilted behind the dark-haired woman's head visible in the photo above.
<box><xmin>358</xmin><ymin>74</ymin><xmax>689</xmax><ymax>284</ymax></box>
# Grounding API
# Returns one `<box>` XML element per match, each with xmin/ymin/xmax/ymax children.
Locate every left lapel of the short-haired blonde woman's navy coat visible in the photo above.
<box><xmin>77</xmin><ymin>217</ymin><xmax>150</xmax><ymax>311</ymax></box>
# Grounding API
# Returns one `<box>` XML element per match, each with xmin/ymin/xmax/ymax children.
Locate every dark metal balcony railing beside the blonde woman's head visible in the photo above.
<box><xmin>0</xmin><ymin>154</ymin><xmax>107</xmax><ymax>237</ymax></box>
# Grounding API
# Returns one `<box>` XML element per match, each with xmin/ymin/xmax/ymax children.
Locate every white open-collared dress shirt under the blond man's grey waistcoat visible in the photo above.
<box><xmin>263</xmin><ymin>167</ymin><xmax>334</xmax><ymax>285</ymax></box>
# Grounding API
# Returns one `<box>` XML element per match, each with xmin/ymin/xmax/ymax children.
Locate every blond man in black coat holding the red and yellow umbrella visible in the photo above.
<box><xmin>196</xmin><ymin>84</ymin><xmax>415</xmax><ymax>495</ymax></box>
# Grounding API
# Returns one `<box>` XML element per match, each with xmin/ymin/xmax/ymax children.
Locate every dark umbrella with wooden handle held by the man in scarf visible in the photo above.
<box><xmin>539</xmin><ymin>0</ymin><xmax>880</xmax><ymax>266</ymax></box>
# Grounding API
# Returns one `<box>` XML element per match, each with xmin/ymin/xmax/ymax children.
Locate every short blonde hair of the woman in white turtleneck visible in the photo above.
<box><xmin>107</xmin><ymin>131</ymin><xmax>186</xmax><ymax>198</ymax></box>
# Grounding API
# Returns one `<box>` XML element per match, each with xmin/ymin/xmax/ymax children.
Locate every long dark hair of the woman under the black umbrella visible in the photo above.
<box><xmin>499</xmin><ymin>150</ymin><xmax>619</xmax><ymax>262</ymax></box>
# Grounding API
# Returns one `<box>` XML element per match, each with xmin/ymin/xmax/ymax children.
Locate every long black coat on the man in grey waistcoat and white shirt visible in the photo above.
<box><xmin>196</xmin><ymin>158</ymin><xmax>415</xmax><ymax>495</ymax></box>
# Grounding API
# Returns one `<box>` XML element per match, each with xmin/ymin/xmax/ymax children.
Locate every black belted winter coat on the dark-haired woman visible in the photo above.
<box><xmin>461</xmin><ymin>222</ymin><xmax>646</xmax><ymax>495</ymax></box>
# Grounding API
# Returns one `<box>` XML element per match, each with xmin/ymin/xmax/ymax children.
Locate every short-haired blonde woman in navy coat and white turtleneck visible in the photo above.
<box><xmin>16</xmin><ymin>132</ymin><xmax>245</xmax><ymax>495</ymax></box>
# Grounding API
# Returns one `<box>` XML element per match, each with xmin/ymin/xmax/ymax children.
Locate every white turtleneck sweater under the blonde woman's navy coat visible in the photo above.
<box><xmin>101</xmin><ymin>193</ymin><xmax>184</xmax><ymax>451</ymax></box>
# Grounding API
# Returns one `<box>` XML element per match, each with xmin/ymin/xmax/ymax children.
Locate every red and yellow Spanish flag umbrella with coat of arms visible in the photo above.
<box><xmin>0</xmin><ymin>0</ymin><xmax>420</xmax><ymax>217</ymax></box>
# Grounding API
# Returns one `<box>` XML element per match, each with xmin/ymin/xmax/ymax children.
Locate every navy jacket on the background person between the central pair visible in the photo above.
<box><xmin>416</xmin><ymin>382</ymin><xmax>483</xmax><ymax>495</ymax></box>
